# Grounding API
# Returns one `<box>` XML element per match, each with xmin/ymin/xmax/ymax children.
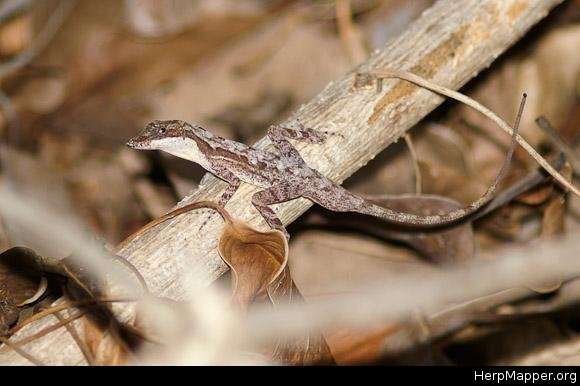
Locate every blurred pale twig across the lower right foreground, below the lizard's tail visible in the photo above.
<box><xmin>245</xmin><ymin>235</ymin><xmax>580</xmax><ymax>346</ymax></box>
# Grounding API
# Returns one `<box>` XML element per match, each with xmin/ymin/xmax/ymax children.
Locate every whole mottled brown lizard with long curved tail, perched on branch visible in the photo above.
<box><xmin>127</xmin><ymin>94</ymin><xmax>526</xmax><ymax>237</ymax></box>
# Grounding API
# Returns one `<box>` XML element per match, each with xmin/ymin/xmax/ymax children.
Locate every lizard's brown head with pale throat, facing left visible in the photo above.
<box><xmin>127</xmin><ymin>121</ymin><xmax>192</xmax><ymax>150</ymax></box>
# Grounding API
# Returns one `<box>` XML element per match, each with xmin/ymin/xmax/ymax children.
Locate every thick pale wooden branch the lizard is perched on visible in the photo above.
<box><xmin>0</xmin><ymin>0</ymin><xmax>561</xmax><ymax>363</ymax></box>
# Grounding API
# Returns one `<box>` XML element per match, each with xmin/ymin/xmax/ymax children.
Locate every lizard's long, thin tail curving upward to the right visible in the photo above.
<box><xmin>353</xmin><ymin>94</ymin><xmax>526</xmax><ymax>227</ymax></box>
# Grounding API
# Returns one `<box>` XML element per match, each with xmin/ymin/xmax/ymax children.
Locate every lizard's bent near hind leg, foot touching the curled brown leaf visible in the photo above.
<box><xmin>252</xmin><ymin>185</ymin><xmax>302</xmax><ymax>239</ymax></box>
